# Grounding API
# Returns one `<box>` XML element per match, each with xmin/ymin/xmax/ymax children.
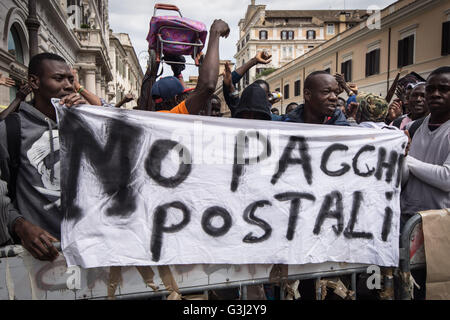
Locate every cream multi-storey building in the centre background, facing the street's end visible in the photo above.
<box><xmin>234</xmin><ymin>0</ymin><xmax>367</xmax><ymax>90</ymax></box>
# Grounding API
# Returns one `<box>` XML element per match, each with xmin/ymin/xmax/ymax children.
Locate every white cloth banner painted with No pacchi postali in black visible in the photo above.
<box><xmin>53</xmin><ymin>102</ymin><xmax>407</xmax><ymax>268</ymax></box>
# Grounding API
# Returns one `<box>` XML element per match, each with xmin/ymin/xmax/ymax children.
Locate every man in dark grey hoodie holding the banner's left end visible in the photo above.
<box><xmin>0</xmin><ymin>53</ymin><xmax>86</xmax><ymax>260</ymax></box>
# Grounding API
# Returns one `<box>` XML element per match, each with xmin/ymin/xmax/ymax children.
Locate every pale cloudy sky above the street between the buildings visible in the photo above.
<box><xmin>109</xmin><ymin>0</ymin><xmax>395</xmax><ymax>77</ymax></box>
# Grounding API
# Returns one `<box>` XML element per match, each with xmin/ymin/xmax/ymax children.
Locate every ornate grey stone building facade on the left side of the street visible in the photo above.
<box><xmin>0</xmin><ymin>0</ymin><xmax>142</xmax><ymax>105</ymax></box>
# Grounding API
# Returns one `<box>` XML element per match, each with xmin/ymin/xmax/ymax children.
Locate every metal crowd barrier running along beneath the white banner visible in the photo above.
<box><xmin>0</xmin><ymin>245</ymin><xmax>368</xmax><ymax>300</ymax></box>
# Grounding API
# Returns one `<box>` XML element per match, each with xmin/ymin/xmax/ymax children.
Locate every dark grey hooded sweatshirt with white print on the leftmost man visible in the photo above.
<box><xmin>0</xmin><ymin>102</ymin><xmax>62</xmax><ymax>238</ymax></box>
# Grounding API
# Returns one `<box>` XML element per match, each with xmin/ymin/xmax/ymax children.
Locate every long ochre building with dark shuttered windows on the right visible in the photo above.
<box><xmin>263</xmin><ymin>0</ymin><xmax>450</xmax><ymax>113</ymax></box>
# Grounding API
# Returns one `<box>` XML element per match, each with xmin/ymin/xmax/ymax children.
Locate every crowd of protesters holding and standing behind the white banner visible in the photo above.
<box><xmin>0</xmin><ymin>16</ymin><xmax>450</xmax><ymax>298</ymax></box>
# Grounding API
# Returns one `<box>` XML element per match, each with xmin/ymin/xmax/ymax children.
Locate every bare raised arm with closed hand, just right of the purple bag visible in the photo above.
<box><xmin>186</xmin><ymin>19</ymin><xmax>230</xmax><ymax>114</ymax></box>
